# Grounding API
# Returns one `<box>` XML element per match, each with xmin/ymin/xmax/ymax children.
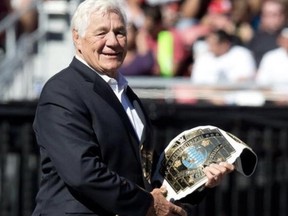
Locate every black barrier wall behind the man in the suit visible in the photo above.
<box><xmin>0</xmin><ymin>100</ymin><xmax>288</xmax><ymax>216</ymax></box>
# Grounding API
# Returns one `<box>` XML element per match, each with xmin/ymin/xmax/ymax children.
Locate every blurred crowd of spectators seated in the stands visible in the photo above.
<box><xmin>0</xmin><ymin>0</ymin><xmax>288</xmax><ymax>85</ymax></box>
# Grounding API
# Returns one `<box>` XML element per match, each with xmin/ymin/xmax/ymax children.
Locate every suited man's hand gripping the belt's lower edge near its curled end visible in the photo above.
<box><xmin>204</xmin><ymin>162</ymin><xmax>235</xmax><ymax>188</ymax></box>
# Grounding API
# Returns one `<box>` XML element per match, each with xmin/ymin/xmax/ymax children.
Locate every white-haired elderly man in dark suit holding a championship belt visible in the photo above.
<box><xmin>33</xmin><ymin>0</ymin><xmax>234</xmax><ymax>216</ymax></box>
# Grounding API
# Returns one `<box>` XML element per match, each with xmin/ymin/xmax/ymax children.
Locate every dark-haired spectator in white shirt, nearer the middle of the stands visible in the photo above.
<box><xmin>191</xmin><ymin>30</ymin><xmax>256</xmax><ymax>85</ymax></box>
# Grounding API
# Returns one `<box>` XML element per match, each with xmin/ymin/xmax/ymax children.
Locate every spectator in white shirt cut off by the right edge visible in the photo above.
<box><xmin>256</xmin><ymin>27</ymin><xmax>288</xmax><ymax>86</ymax></box>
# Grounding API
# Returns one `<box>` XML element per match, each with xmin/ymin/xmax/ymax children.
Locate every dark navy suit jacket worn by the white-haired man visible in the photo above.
<box><xmin>33</xmin><ymin>58</ymin><xmax>153</xmax><ymax>216</ymax></box>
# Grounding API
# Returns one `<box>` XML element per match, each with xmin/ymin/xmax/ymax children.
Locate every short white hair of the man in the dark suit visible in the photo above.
<box><xmin>71</xmin><ymin>0</ymin><xmax>127</xmax><ymax>37</ymax></box>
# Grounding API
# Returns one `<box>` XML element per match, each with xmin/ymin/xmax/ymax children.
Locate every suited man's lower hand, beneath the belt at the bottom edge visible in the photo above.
<box><xmin>146</xmin><ymin>188</ymin><xmax>187</xmax><ymax>216</ymax></box>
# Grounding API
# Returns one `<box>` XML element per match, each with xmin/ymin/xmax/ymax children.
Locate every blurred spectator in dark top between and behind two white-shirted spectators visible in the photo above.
<box><xmin>248</xmin><ymin>0</ymin><xmax>286</xmax><ymax>67</ymax></box>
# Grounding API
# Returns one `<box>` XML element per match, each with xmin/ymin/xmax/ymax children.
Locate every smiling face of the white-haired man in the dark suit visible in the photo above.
<box><xmin>73</xmin><ymin>12</ymin><xmax>127</xmax><ymax>78</ymax></box>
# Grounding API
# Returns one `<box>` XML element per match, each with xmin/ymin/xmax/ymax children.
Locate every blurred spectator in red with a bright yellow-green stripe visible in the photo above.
<box><xmin>141</xmin><ymin>5</ymin><xmax>188</xmax><ymax>77</ymax></box>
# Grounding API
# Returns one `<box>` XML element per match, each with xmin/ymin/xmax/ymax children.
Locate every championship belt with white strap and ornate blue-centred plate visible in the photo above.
<box><xmin>154</xmin><ymin>126</ymin><xmax>257</xmax><ymax>200</ymax></box>
